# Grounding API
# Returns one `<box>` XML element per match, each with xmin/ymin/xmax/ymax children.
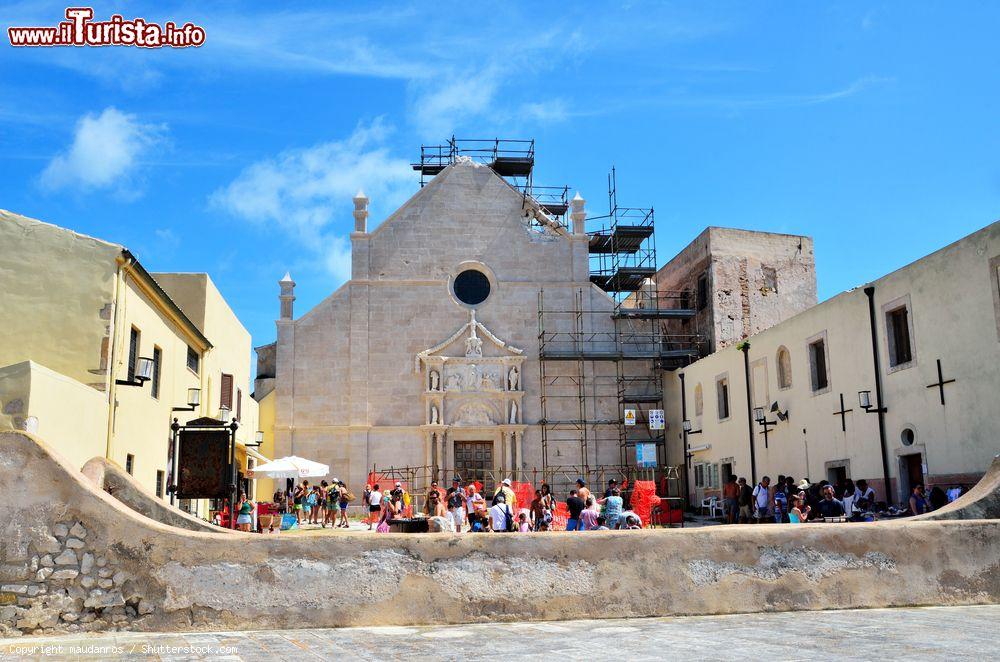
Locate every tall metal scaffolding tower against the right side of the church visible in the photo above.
<box><xmin>538</xmin><ymin>169</ymin><xmax>704</xmax><ymax>468</ymax></box>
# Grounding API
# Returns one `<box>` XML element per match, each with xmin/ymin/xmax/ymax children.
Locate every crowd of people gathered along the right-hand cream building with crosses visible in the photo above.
<box><xmin>722</xmin><ymin>476</ymin><xmax>962</xmax><ymax>524</ymax></box>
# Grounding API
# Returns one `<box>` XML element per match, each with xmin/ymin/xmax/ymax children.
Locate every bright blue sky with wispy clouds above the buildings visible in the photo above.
<box><xmin>0</xmin><ymin>2</ymin><xmax>1000</xmax><ymax>352</ymax></box>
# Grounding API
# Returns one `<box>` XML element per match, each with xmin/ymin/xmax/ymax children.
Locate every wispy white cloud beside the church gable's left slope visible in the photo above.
<box><xmin>210</xmin><ymin>118</ymin><xmax>417</xmax><ymax>280</ymax></box>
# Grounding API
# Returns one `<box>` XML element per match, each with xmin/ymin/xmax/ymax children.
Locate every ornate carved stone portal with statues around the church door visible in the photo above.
<box><xmin>415</xmin><ymin>309</ymin><xmax>525</xmax><ymax>480</ymax></box>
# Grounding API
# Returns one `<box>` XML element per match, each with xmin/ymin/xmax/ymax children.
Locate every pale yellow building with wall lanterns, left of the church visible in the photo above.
<box><xmin>0</xmin><ymin>210</ymin><xmax>263</xmax><ymax>517</ymax></box>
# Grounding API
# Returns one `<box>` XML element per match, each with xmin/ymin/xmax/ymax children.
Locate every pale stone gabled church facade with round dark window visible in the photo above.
<box><xmin>257</xmin><ymin>159</ymin><xmax>620</xmax><ymax>487</ymax></box>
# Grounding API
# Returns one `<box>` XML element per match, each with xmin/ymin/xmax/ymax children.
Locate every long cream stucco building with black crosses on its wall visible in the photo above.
<box><xmin>664</xmin><ymin>223</ymin><xmax>1000</xmax><ymax>503</ymax></box>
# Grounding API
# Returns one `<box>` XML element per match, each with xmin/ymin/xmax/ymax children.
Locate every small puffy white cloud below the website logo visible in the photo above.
<box><xmin>41</xmin><ymin>107</ymin><xmax>166</xmax><ymax>196</ymax></box>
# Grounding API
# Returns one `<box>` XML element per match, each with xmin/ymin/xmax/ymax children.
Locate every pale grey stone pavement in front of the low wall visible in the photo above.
<box><xmin>0</xmin><ymin>605</ymin><xmax>1000</xmax><ymax>662</ymax></box>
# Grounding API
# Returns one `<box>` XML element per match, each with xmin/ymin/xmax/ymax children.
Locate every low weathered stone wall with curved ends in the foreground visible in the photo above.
<box><xmin>0</xmin><ymin>432</ymin><xmax>1000</xmax><ymax>636</ymax></box>
